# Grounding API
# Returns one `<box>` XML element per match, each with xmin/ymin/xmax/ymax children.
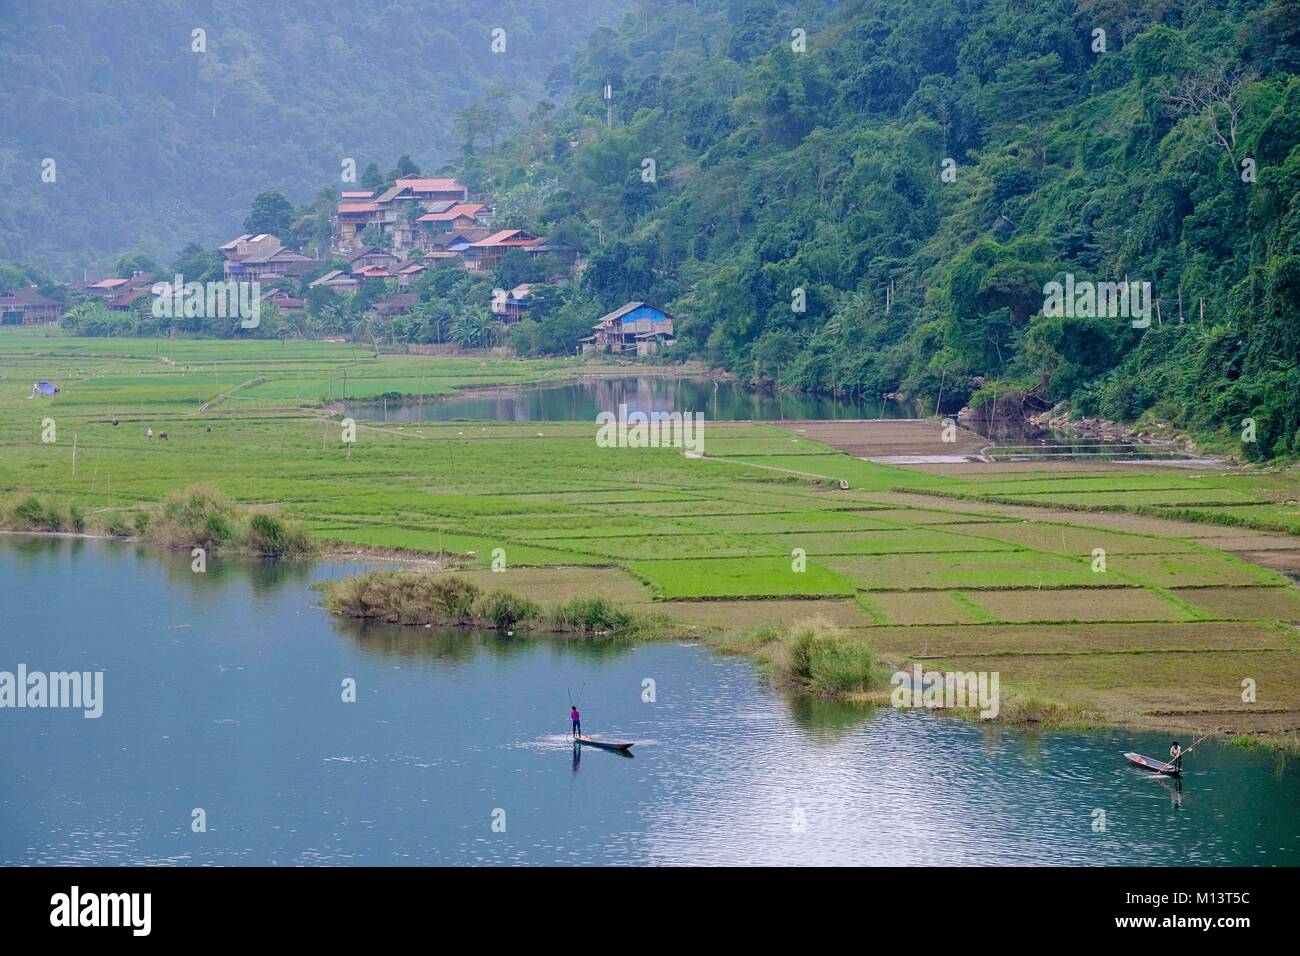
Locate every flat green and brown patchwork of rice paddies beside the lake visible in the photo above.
<box><xmin>0</xmin><ymin>330</ymin><xmax>1300</xmax><ymax>732</ymax></box>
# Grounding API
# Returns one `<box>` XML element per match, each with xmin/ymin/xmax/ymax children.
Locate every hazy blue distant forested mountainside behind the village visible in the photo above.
<box><xmin>0</xmin><ymin>0</ymin><xmax>627</xmax><ymax>278</ymax></box>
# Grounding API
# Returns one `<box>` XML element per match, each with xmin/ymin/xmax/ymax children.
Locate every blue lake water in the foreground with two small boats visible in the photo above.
<box><xmin>0</xmin><ymin>536</ymin><xmax>1300</xmax><ymax>865</ymax></box>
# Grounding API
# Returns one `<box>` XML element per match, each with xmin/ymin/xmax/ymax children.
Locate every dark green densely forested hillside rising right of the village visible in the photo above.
<box><xmin>478</xmin><ymin>0</ymin><xmax>1300</xmax><ymax>457</ymax></box>
